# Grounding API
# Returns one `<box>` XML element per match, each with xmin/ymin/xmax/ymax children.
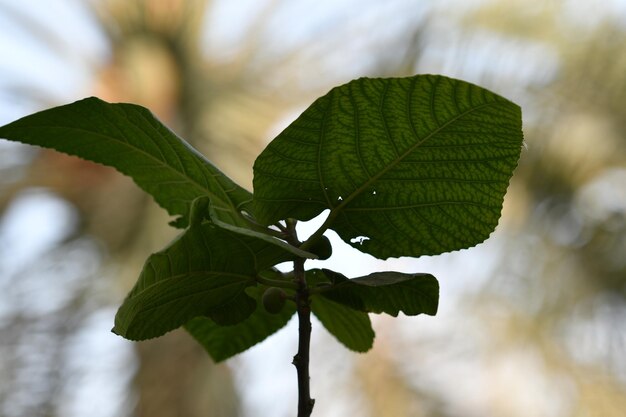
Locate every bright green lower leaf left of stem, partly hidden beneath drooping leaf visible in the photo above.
<box><xmin>185</xmin><ymin>286</ymin><xmax>296</xmax><ymax>362</ymax></box>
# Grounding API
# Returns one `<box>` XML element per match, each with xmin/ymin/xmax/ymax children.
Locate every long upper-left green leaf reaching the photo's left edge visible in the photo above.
<box><xmin>0</xmin><ymin>97</ymin><xmax>252</xmax><ymax>227</ymax></box>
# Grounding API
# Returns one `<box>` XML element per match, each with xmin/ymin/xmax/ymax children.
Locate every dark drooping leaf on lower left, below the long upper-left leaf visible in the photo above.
<box><xmin>113</xmin><ymin>221</ymin><xmax>293</xmax><ymax>340</ymax></box>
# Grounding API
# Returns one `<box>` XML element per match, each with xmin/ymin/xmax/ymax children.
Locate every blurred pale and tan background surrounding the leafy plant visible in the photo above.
<box><xmin>0</xmin><ymin>0</ymin><xmax>626</xmax><ymax>417</ymax></box>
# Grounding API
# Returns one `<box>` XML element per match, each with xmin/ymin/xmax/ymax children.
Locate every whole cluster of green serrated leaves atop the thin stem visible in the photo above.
<box><xmin>0</xmin><ymin>75</ymin><xmax>522</xmax><ymax>361</ymax></box>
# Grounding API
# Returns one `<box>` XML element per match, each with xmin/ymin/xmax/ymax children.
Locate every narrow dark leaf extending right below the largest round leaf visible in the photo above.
<box><xmin>307</xmin><ymin>269</ymin><xmax>439</xmax><ymax>317</ymax></box>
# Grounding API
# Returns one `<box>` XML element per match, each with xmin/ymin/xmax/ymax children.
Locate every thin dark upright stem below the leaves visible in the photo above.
<box><xmin>293</xmin><ymin>259</ymin><xmax>315</xmax><ymax>417</ymax></box>
